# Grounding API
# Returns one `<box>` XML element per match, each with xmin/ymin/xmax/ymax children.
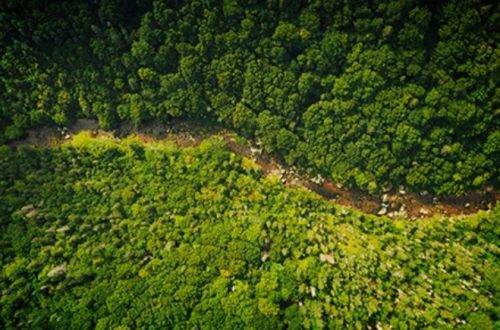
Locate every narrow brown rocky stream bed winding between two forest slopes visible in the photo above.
<box><xmin>10</xmin><ymin>120</ymin><xmax>500</xmax><ymax>219</ymax></box>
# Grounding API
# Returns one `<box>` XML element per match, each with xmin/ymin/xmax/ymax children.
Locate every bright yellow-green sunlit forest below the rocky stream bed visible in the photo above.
<box><xmin>0</xmin><ymin>134</ymin><xmax>500</xmax><ymax>329</ymax></box>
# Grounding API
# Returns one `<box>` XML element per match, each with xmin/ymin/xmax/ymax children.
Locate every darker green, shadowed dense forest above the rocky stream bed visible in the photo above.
<box><xmin>0</xmin><ymin>0</ymin><xmax>500</xmax><ymax>194</ymax></box>
